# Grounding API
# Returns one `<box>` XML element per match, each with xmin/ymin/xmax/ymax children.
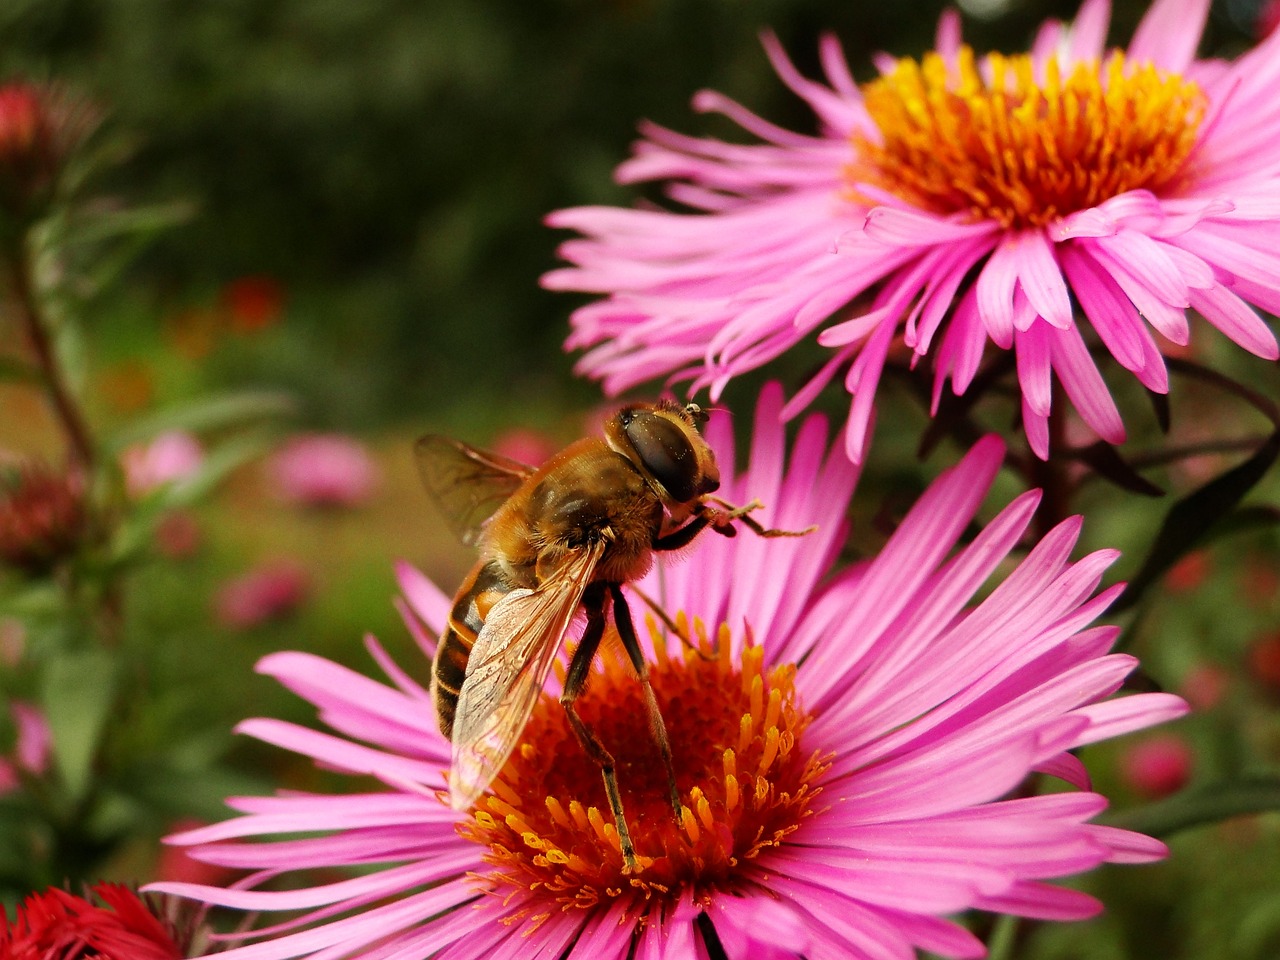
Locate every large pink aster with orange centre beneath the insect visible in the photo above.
<box><xmin>155</xmin><ymin>388</ymin><xmax>1185</xmax><ymax>960</ymax></box>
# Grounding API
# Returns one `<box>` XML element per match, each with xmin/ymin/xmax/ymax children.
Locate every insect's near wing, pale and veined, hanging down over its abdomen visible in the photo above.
<box><xmin>449</xmin><ymin>543</ymin><xmax>604</xmax><ymax>810</ymax></box>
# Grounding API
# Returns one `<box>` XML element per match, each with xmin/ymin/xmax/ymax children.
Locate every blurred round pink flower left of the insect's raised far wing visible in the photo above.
<box><xmin>268</xmin><ymin>434</ymin><xmax>378</xmax><ymax>507</ymax></box>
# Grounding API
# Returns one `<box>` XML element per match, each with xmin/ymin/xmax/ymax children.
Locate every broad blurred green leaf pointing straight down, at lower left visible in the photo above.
<box><xmin>41</xmin><ymin>650</ymin><xmax>115</xmax><ymax>800</ymax></box>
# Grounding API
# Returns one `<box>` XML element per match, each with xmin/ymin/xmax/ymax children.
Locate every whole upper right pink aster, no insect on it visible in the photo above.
<box><xmin>544</xmin><ymin>0</ymin><xmax>1280</xmax><ymax>458</ymax></box>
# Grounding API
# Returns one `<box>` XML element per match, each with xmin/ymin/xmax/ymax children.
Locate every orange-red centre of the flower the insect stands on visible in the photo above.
<box><xmin>460</xmin><ymin>622</ymin><xmax>826</xmax><ymax>927</ymax></box>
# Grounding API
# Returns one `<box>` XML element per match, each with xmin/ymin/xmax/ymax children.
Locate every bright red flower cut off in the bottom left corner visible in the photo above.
<box><xmin>0</xmin><ymin>883</ymin><xmax>183</xmax><ymax>960</ymax></box>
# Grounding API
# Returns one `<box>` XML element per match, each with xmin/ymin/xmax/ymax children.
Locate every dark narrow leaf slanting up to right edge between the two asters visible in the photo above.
<box><xmin>1111</xmin><ymin>430</ymin><xmax>1280</xmax><ymax>612</ymax></box>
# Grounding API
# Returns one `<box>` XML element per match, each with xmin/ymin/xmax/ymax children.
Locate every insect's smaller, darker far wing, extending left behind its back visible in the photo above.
<box><xmin>413</xmin><ymin>434</ymin><xmax>534</xmax><ymax>545</ymax></box>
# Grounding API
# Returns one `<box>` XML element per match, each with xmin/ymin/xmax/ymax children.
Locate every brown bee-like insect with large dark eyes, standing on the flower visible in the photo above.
<box><xmin>417</xmin><ymin>402</ymin><xmax>808</xmax><ymax>870</ymax></box>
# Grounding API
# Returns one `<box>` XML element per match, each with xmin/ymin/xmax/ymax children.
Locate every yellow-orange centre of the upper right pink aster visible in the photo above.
<box><xmin>845</xmin><ymin>47</ymin><xmax>1206</xmax><ymax>229</ymax></box>
